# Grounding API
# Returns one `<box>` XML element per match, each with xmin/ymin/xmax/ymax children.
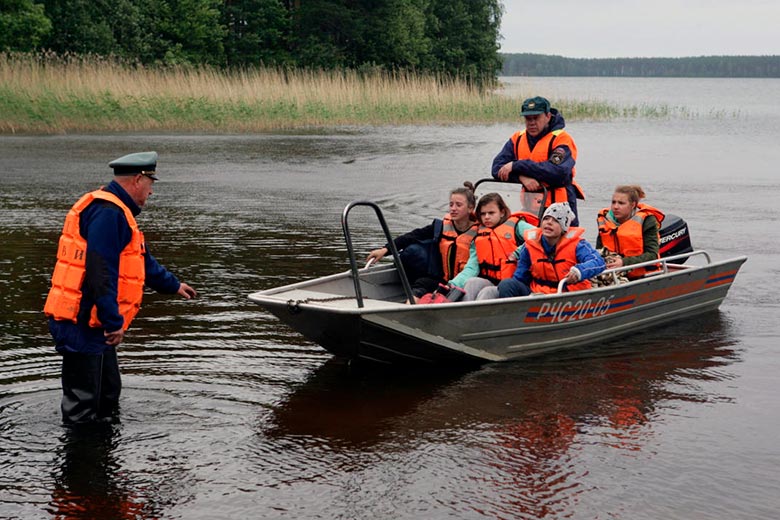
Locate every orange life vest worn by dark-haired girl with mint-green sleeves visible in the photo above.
<box><xmin>474</xmin><ymin>215</ymin><xmax>520</xmax><ymax>283</ymax></box>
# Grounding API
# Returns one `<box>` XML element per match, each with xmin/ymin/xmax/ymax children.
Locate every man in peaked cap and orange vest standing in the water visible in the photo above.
<box><xmin>44</xmin><ymin>152</ymin><xmax>197</xmax><ymax>424</ymax></box>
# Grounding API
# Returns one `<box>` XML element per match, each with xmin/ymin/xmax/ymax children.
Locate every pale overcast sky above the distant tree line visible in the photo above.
<box><xmin>501</xmin><ymin>0</ymin><xmax>780</xmax><ymax>58</ymax></box>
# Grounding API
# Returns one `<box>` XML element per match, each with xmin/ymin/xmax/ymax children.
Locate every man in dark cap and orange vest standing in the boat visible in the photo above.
<box><xmin>491</xmin><ymin>96</ymin><xmax>585</xmax><ymax>226</ymax></box>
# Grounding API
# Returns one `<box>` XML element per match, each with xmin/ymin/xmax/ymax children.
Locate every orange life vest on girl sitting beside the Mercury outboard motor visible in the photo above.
<box><xmin>596</xmin><ymin>203</ymin><xmax>665</xmax><ymax>280</ymax></box>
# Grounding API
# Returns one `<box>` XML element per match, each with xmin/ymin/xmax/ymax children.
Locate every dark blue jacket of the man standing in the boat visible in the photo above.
<box><xmin>491</xmin><ymin>108</ymin><xmax>579</xmax><ymax>226</ymax></box>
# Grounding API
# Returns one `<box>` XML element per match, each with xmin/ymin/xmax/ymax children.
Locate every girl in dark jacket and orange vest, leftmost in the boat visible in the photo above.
<box><xmin>366</xmin><ymin>181</ymin><xmax>477</xmax><ymax>301</ymax></box>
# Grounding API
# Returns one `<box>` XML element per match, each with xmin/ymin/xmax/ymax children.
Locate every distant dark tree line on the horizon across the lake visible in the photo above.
<box><xmin>501</xmin><ymin>54</ymin><xmax>780</xmax><ymax>78</ymax></box>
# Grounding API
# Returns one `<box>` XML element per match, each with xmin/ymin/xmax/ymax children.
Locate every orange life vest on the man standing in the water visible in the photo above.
<box><xmin>43</xmin><ymin>190</ymin><xmax>145</xmax><ymax>330</ymax></box>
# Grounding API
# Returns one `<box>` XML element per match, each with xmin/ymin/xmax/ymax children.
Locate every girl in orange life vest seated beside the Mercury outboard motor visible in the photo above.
<box><xmin>596</xmin><ymin>186</ymin><xmax>664</xmax><ymax>279</ymax></box>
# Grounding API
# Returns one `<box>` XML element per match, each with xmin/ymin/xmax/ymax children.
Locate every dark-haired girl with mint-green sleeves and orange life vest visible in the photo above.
<box><xmin>449</xmin><ymin>193</ymin><xmax>536</xmax><ymax>301</ymax></box>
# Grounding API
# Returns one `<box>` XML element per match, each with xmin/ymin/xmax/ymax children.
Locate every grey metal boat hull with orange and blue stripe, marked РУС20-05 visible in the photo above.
<box><xmin>250</xmin><ymin>257</ymin><xmax>746</xmax><ymax>366</ymax></box>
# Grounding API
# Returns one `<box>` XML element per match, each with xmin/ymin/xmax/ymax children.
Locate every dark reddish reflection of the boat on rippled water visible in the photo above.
<box><xmin>263</xmin><ymin>313</ymin><xmax>739</xmax><ymax>518</ymax></box>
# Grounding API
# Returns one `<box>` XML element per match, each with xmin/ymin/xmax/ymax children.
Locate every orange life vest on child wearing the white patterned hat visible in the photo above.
<box><xmin>524</xmin><ymin>227</ymin><xmax>591</xmax><ymax>293</ymax></box>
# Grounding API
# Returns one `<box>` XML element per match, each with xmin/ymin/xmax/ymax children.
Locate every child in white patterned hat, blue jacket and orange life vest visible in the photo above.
<box><xmin>498</xmin><ymin>202</ymin><xmax>606</xmax><ymax>298</ymax></box>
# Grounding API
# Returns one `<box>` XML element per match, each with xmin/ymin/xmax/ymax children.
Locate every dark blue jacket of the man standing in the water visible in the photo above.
<box><xmin>49</xmin><ymin>181</ymin><xmax>180</xmax><ymax>353</ymax></box>
